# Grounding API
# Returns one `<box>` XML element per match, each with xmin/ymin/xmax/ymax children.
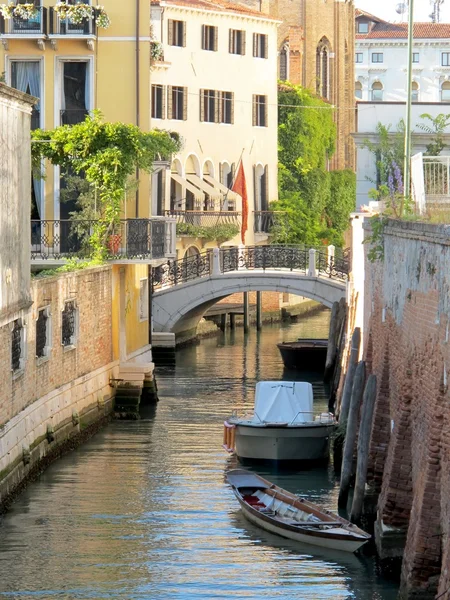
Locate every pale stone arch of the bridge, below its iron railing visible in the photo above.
<box><xmin>152</xmin><ymin>271</ymin><xmax>346</xmax><ymax>334</ymax></box>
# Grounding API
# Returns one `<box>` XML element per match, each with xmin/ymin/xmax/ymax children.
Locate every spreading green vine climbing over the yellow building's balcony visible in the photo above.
<box><xmin>32</xmin><ymin>111</ymin><xmax>180</xmax><ymax>258</ymax></box>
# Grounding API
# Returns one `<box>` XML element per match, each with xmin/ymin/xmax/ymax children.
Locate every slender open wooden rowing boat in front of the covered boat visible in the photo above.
<box><xmin>227</xmin><ymin>469</ymin><xmax>371</xmax><ymax>552</ymax></box>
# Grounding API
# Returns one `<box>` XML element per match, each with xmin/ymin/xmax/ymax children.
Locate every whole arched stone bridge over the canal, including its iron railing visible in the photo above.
<box><xmin>152</xmin><ymin>246</ymin><xmax>349</xmax><ymax>334</ymax></box>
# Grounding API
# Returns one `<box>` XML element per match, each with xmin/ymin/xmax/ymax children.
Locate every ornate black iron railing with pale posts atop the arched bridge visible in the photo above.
<box><xmin>152</xmin><ymin>245</ymin><xmax>350</xmax><ymax>291</ymax></box>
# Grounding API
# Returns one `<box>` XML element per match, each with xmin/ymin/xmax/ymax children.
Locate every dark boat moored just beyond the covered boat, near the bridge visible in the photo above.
<box><xmin>277</xmin><ymin>338</ymin><xmax>328</xmax><ymax>371</ymax></box>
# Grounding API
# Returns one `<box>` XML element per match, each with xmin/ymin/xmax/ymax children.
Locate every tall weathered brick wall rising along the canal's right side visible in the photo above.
<box><xmin>364</xmin><ymin>221</ymin><xmax>450</xmax><ymax>600</ymax></box>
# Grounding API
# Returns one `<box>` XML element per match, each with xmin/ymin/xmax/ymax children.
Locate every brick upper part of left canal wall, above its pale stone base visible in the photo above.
<box><xmin>0</xmin><ymin>267</ymin><xmax>112</xmax><ymax>425</ymax></box>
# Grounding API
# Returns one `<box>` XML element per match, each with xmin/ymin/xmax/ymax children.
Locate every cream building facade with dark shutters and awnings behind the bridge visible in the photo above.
<box><xmin>150</xmin><ymin>0</ymin><xmax>279</xmax><ymax>258</ymax></box>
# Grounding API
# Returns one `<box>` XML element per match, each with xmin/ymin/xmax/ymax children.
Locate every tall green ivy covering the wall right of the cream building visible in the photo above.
<box><xmin>271</xmin><ymin>84</ymin><xmax>356</xmax><ymax>246</ymax></box>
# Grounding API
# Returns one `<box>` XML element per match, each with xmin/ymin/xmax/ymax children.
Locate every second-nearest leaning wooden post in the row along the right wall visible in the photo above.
<box><xmin>338</xmin><ymin>360</ymin><xmax>366</xmax><ymax>508</ymax></box>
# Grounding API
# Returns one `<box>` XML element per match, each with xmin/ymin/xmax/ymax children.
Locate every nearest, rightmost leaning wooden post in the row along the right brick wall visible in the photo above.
<box><xmin>350</xmin><ymin>375</ymin><xmax>377</xmax><ymax>523</ymax></box>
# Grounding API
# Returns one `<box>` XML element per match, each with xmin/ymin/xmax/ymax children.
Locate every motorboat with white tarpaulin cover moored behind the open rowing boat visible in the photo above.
<box><xmin>224</xmin><ymin>381</ymin><xmax>336</xmax><ymax>462</ymax></box>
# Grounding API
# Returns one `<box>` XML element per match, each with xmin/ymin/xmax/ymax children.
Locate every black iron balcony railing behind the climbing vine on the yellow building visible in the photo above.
<box><xmin>31</xmin><ymin>217</ymin><xmax>175</xmax><ymax>261</ymax></box>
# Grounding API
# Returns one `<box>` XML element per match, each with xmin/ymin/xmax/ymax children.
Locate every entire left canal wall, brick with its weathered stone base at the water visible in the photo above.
<box><xmin>0</xmin><ymin>267</ymin><xmax>118</xmax><ymax>506</ymax></box>
